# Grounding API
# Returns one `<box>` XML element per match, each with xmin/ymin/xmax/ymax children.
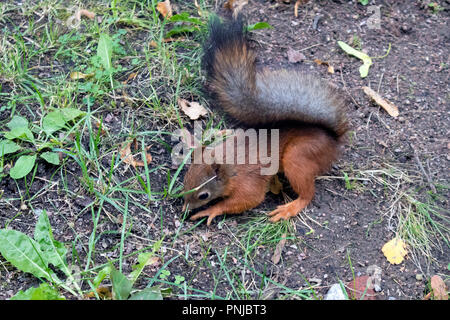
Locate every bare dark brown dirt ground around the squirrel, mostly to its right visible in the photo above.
<box><xmin>0</xmin><ymin>0</ymin><xmax>450</xmax><ymax>300</ymax></box>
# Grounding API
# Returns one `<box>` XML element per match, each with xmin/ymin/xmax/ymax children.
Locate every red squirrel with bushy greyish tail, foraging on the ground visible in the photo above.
<box><xmin>184</xmin><ymin>16</ymin><xmax>348</xmax><ymax>226</ymax></box>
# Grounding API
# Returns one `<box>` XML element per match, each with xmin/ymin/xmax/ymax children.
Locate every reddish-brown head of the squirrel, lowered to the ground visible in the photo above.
<box><xmin>183</xmin><ymin>164</ymin><xmax>225</xmax><ymax>211</ymax></box>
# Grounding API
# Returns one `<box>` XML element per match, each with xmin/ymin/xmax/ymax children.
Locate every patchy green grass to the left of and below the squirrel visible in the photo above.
<box><xmin>0</xmin><ymin>0</ymin><xmax>310</xmax><ymax>299</ymax></box>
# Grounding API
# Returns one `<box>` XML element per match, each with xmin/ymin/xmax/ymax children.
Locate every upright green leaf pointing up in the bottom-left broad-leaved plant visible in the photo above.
<box><xmin>34</xmin><ymin>210</ymin><xmax>70</xmax><ymax>276</ymax></box>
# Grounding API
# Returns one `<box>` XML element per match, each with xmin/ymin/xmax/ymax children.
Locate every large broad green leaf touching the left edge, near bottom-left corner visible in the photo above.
<box><xmin>0</xmin><ymin>229</ymin><xmax>52</xmax><ymax>280</ymax></box>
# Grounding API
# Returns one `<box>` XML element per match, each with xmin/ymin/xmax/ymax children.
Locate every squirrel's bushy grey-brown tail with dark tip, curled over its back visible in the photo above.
<box><xmin>203</xmin><ymin>16</ymin><xmax>347</xmax><ymax>138</ymax></box>
